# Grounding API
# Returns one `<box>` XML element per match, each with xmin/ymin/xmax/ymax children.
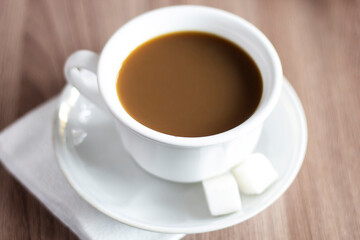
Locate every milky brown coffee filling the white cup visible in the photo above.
<box><xmin>117</xmin><ymin>32</ymin><xmax>262</xmax><ymax>137</ymax></box>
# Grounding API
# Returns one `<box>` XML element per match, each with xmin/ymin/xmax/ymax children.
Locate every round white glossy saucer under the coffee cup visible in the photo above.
<box><xmin>54</xmin><ymin>80</ymin><xmax>307</xmax><ymax>233</ymax></box>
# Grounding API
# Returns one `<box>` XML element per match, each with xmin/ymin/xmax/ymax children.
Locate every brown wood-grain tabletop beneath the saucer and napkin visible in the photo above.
<box><xmin>0</xmin><ymin>0</ymin><xmax>360</xmax><ymax>240</ymax></box>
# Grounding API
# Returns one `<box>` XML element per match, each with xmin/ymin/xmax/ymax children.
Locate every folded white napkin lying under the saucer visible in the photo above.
<box><xmin>0</xmin><ymin>98</ymin><xmax>184</xmax><ymax>240</ymax></box>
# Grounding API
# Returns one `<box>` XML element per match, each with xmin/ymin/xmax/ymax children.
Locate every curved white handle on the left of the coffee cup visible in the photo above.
<box><xmin>64</xmin><ymin>50</ymin><xmax>107</xmax><ymax>111</ymax></box>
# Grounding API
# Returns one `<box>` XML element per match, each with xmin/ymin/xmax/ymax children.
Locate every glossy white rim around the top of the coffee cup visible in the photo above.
<box><xmin>98</xmin><ymin>5</ymin><xmax>283</xmax><ymax>147</ymax></box>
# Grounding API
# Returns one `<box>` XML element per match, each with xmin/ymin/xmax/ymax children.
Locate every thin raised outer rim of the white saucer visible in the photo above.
<box><xmin>52</xmin><ymin>76</ymin><xmax>308</xmax><ymax>234</ymax></box>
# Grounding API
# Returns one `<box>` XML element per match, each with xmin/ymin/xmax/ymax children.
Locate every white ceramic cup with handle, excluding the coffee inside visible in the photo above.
<box><xmin>64</xmin><ymin>5</ymin><xmax>283</xmax><ymax>182</ymax></box>
